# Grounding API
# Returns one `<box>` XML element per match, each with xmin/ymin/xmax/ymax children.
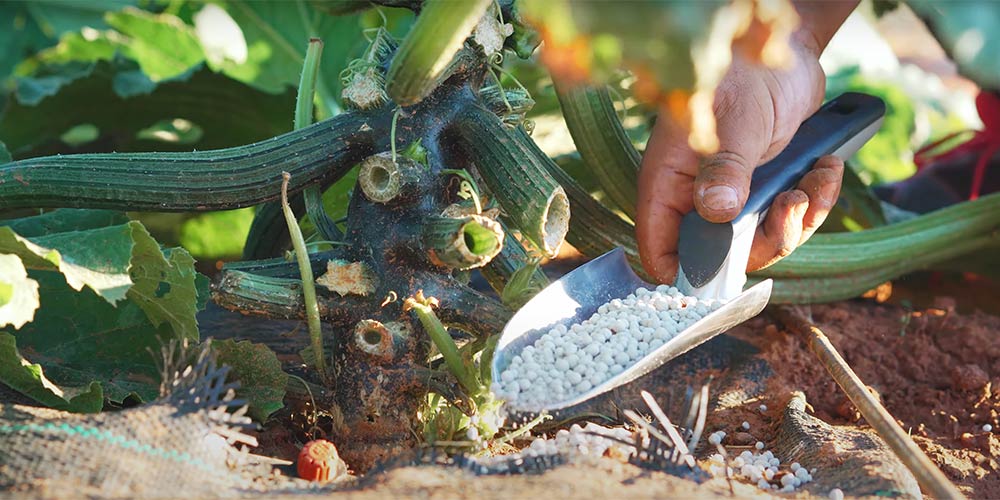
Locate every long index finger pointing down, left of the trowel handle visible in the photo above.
<box><xmin>635</xmin><ymin>113</ymin><xmax>698</xmax><ymax>283</ymax></box>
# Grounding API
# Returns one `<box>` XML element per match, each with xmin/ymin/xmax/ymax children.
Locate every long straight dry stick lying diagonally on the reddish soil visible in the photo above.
<box><xmin>771</xmin><ymin>306</ymin><xmax>965</xmax><ymax>499</ymax></box>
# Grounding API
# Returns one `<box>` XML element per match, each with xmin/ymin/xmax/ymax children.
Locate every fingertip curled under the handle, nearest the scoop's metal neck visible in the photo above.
<box><xmin>747</xmin><ymin>189</ymin><xmax>809</xmax><ymax>272</ymax></box>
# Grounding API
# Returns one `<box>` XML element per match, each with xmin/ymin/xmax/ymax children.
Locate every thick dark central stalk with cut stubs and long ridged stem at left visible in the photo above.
<box><xmin>0</xmin><ymin>0</ymin><xmax>570</xmax><ymax>469</ymax></box>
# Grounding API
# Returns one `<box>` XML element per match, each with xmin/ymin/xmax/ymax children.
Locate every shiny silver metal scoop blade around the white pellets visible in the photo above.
<box><xmin>492</xmin><ymin>248</ymin><xmax>772</xmax><ymax>412</ymax></box>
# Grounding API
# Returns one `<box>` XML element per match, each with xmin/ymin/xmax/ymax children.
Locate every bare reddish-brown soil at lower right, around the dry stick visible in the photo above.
<box><xmin>733</xmin><ymin>298</ymin><xmax>1000</xmax><ymax>498</ymax></box>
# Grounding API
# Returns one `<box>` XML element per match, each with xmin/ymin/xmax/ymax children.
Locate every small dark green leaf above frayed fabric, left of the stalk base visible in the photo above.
<box><xmin>212</xmin><ymin>339</ymin><xmax>288</xmax><ymax>422</ymax></box>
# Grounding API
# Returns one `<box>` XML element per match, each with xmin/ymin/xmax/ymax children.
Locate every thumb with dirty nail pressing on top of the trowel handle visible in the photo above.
<box><xmin>694</xmin><ymin>75</ymin><xmax>774</xmax><ymax>222</ymax></box>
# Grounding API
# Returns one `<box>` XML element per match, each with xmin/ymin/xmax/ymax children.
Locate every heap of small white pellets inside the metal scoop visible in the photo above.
<box><xmin>493</xmin><ymin>285</ymin><xmax>722</xmax><ymax>409</ymax></box>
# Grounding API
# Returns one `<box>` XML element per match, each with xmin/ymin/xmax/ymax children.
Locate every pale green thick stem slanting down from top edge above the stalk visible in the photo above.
<box><xmin>386</xmin><ymin>0</ymin><xmax>492</xmax><ymax>106</ymax></box>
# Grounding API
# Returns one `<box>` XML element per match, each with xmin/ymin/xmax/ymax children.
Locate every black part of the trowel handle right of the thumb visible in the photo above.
<box><xmin>734</xmin><ymin>92</ymin><xmax>885</xmax><ymax>222</ymax></box>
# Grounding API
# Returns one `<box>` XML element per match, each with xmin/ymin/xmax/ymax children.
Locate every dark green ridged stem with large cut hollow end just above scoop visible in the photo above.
<box><xmin>453</xmin><ymin>111</ymin><xmax>570</xmax><ymax>257</ymax></box>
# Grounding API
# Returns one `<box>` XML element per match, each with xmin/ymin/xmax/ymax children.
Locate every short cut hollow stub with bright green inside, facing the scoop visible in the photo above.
<box><xmin>423</xmin><ymin>215</ymin><xmax>504</xmax><ymax>270</ymax></box>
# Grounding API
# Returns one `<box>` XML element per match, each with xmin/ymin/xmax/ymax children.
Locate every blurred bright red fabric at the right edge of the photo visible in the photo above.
<box><xmin>913</xmin><ymin>90</ymin><xmax>1000</xmax><ymax>200</ymax></box>
